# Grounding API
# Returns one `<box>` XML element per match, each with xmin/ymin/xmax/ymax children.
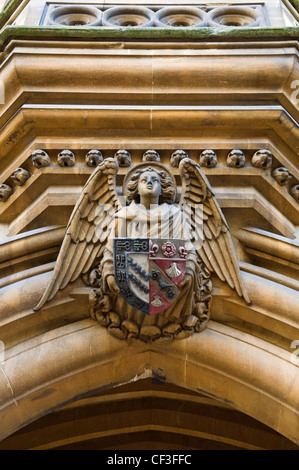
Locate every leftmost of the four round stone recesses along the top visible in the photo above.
<box><xmin>49</xmin><ymin>6</ymin><xmax>102</xmax><ymax>26</ymax></box>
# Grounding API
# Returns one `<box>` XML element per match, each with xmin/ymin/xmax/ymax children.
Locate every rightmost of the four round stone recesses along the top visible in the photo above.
<box><xmin>208</xmin><ymin>7</ymin><xmax>260</xmax><ymax>27</ymax></box>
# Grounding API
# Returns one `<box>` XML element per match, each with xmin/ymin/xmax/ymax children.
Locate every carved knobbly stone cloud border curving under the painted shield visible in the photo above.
<box><xmin>87</xmin><ymin>263</ymin><xmax>213</xmax><ymax>343</ymax></box>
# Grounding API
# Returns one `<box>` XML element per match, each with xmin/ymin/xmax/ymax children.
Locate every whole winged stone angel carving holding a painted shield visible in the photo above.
<box><xmin>35</xmin><ymin>158</ymin><xmax>250</xmax><ymax>342</ymax></box>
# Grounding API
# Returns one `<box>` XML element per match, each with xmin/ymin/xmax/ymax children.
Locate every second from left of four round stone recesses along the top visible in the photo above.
<box><xmin>103</xmin><ymin>7</ymin><xmax>155</xmax><ymax>28</ymax></box>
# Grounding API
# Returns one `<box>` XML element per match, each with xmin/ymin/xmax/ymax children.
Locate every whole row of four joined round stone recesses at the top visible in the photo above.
<box><xmin>43</xmin><ymin>4</ymin><xmax>265</xmax><ymax>28</ymax></box>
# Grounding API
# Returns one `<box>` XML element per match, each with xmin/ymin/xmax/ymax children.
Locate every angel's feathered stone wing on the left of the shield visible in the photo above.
<box><xmin>34</xmin><ymin>158</ymin><xmax>122</xmax><ymax>310</ymax></box>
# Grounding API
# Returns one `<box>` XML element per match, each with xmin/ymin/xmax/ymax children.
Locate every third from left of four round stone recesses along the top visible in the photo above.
<box><xmin>156</xmin><ymin>7</ymin><xmax>207</xmax><ymax>28</ymax></box>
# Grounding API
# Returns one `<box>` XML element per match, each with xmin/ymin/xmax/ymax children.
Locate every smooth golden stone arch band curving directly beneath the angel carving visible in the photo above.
<box><xmin>0</xmin><ymin>288</ymin><xmax>298</xmax><ymax>443</ymax></box>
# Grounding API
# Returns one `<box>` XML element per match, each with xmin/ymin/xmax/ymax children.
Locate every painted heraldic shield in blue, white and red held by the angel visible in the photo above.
<box><xmin>113</xmin><ymin>238</ymin><xmax>187</xmax><ymax>315</ymax></box>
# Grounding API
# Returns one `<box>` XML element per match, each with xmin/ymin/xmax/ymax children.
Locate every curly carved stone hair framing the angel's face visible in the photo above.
<box><xmin>127</xmin><ymin>166</ymin><xmax>175</xmax><ymax>204</ymax></box>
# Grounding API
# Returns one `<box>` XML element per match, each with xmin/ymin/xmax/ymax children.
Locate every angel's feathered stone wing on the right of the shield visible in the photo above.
<box><xmin>179</xmin><ymin>158</ymin><xmax>250</xmax><ymax>303</ymax></box>
